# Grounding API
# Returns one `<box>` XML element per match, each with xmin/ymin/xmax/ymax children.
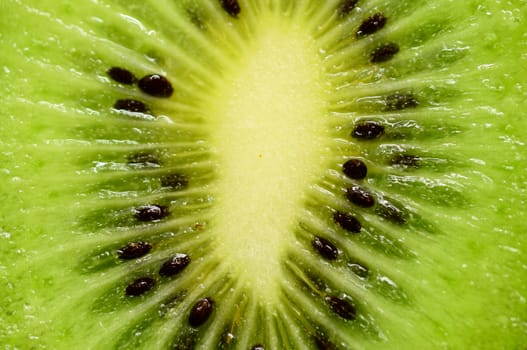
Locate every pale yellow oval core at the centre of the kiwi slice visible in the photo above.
<box><xmin>210</xmin><ymin>19</ymin><xmax>328</xmax><ymax>302</ymax></box>
